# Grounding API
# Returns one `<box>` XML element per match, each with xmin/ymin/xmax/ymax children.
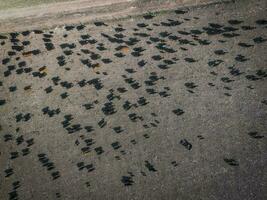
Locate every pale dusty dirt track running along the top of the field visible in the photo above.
<box><xmin>0</xmin><ymin>0</ymin><xmax>224</xmax><ymax>33</ymax></box>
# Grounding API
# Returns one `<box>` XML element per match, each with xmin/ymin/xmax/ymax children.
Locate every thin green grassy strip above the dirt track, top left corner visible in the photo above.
<box><xmin>0</xmin><ymin>0</ymin><xmax>74</xmax><ymax>10</ymax></box>
